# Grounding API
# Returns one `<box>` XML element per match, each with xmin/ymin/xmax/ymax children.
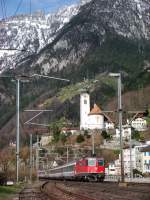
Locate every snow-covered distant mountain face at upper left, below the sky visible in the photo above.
<box><xmin>0</xmin><ymin>0</ymin><xmax>89</xmax><ymax>72</ymax></box>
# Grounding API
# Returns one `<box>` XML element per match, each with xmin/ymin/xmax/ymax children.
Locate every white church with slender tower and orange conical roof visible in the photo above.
<box><xmin>80</xmin><ymin>90</ymin><xmax>114</xmax><ymax>130</ymax></box>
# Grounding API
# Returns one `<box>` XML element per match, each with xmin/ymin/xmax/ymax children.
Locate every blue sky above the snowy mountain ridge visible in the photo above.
<box><xmin>0</xmin><ymin>0</ymin><xmax>79</xmax><ymax>19</ymax></box>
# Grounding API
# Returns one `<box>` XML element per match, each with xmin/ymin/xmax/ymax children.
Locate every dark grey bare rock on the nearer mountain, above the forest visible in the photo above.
<box><xmin>31</xmin><ymin>0</ymin><xmax>150</xmax><ymax>74</ymax></box>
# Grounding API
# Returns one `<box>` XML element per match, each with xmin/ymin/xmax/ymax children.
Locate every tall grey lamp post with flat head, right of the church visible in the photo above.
<box><xmin>109</xmin><ymin>73</ymin><xmax>124</xmax><ymax>182</ymax></box>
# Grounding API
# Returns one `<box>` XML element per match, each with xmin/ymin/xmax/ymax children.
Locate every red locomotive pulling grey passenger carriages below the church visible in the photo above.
<box><xmin>39</xmin><ymin>157</ymin><xmax>105</xmax><ymax>182</ymax></box>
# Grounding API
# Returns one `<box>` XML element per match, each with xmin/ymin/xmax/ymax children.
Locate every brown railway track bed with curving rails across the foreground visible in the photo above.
<box><xmin>19</xmin><ymin>181</ymin><xmax>150</xmax><ymax>200</ymax></box>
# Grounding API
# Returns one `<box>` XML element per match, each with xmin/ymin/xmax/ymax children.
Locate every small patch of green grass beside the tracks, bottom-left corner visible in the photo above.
<box><xmin>0</xmin><ymin>185</ymin><xmax>21</xmax><ymax>200</ymax></box>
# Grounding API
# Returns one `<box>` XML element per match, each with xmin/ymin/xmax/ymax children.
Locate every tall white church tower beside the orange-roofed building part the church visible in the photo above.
<box><xmin>80</xmin><ymin>89</ymin><xmax>90</xmax><ymax>130</ymax></box>
